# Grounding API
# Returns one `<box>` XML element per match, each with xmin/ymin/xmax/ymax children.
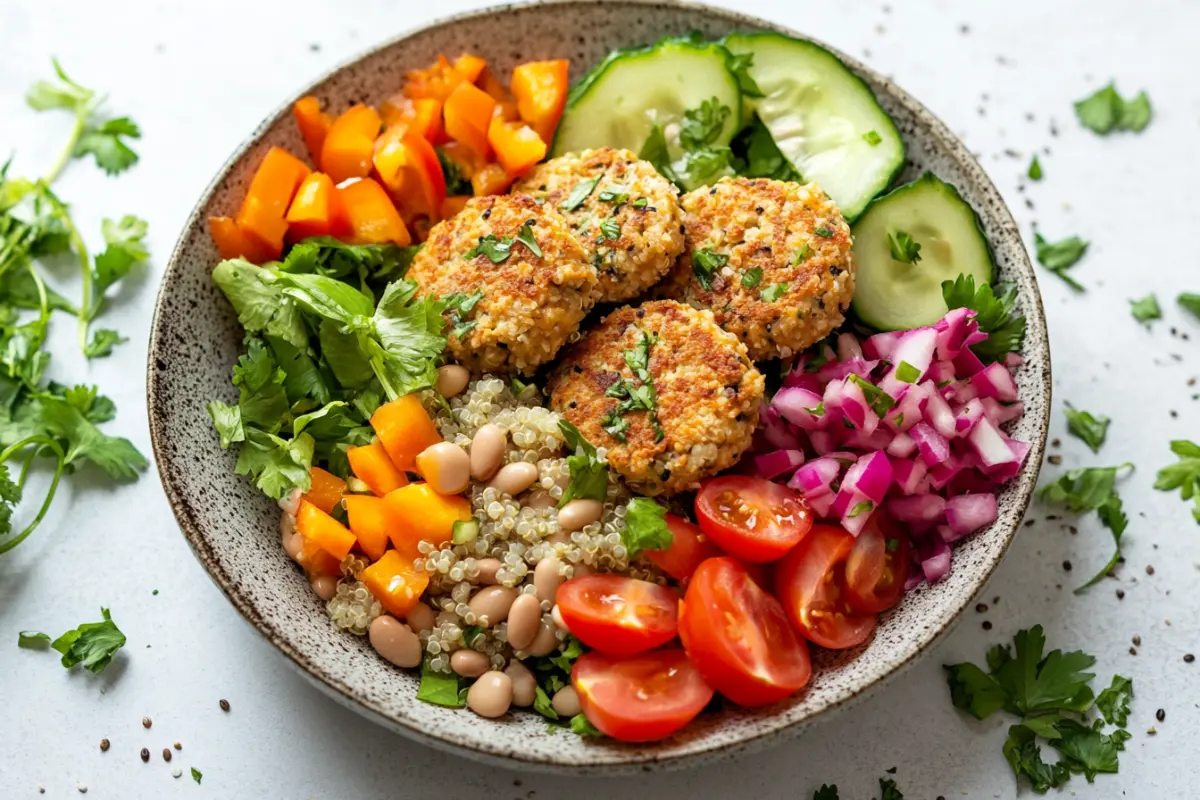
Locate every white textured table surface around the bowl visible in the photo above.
<box><xmin>0</xmin><ymin>0</ymin><xmax>1200</xmax><ymax>800</ymax></box>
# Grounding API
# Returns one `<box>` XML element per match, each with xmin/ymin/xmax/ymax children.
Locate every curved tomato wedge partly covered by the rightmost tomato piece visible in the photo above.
<box><xmin>775</xmin><ymin>525</ymin><xmax>878</xmax><ymax>650</ymax></box>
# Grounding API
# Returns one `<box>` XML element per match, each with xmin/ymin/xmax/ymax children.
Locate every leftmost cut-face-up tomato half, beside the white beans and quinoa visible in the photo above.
<box><xmin>554</xmin><ymin>575</ymin><xmax>679</xmax><ymax>656</ymax></box>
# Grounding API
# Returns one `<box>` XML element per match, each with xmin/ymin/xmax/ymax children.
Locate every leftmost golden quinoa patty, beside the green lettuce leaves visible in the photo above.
<box><xmin>408</xmin><ymin>196</ymin><xmax>596</xmax><ymax>374</ymax></box>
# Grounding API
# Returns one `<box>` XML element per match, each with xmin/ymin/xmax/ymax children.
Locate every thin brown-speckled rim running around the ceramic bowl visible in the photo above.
<box><xmin>146</xmin><ymin>0</ymin><xmax>1052</xmax><ymax>775</ymax></box>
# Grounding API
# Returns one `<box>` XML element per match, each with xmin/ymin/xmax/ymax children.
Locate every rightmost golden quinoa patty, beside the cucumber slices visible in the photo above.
<box><xmin>659</xmin><ymin>178</ymin><xmax>854</xmax><ymax>361</ymax></box>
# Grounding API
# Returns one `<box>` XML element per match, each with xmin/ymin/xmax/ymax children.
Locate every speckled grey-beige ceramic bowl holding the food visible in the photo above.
<box><xmin>148</xmin><ymin>0</ymin><xmax>1050</xmax><ymax>772</ymax></box>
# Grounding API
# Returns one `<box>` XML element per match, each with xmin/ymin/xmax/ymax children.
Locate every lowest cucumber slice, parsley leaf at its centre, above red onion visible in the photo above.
<box><xmin>852</xmin><ymin>173</ymin><xmax>995</xmax><ymax>331</ymax></box>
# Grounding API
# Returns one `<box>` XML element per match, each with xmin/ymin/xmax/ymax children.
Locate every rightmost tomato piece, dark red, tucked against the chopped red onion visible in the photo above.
<box><xmin>846</xmin><ymin>511</ymin><xmax>912</xmax><ymax>614</ymax></box>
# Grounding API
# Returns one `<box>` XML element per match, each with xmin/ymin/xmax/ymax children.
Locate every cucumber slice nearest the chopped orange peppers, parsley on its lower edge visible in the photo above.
<box><xmin>551</xmin><ymin>38</ymin><xmax>742</xmax><ymax>172</ymax></box>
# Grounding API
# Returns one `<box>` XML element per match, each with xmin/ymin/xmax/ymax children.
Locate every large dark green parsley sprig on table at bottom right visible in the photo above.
<box><xmin>944</xmin><ymin>625</ymin><xmax>1133</xmax><ymax>794</ymax></box>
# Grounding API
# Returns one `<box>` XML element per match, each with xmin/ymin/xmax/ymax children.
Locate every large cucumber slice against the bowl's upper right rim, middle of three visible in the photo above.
<box><xmin>724</xmin><ymin>34</ymin><xmax>905</xmax><ymax>222</ymax></box>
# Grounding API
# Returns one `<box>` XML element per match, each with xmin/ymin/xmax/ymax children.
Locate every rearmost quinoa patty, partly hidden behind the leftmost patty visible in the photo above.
<box><xmin>515</xmin><ymin>148</ymin><xmax>683</xmax><ymax>302</ymax></box>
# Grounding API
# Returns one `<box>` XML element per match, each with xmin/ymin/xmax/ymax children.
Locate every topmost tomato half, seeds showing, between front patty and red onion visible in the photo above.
<box><xmin>696</xmin><ymin>475</ymin><xmax>812</xmax><ymax>563</ymax></box>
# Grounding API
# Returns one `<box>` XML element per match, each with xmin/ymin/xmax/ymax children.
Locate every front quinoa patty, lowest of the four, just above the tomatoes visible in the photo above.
<box><xmin>548</xmin><ymin>300</ymin><xmax>763</xmax><ymax>495</ymax></box>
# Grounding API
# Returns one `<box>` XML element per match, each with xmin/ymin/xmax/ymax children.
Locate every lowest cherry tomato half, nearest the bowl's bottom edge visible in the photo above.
<box><xmin>571</xmin><ymin>648</ymin><xmax>713</xmax><ymax>741</ymax></box>
